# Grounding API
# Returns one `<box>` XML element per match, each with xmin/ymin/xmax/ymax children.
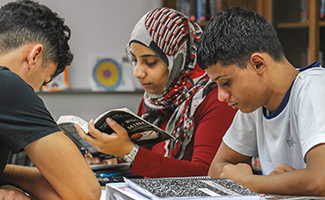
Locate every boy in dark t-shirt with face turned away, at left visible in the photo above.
<box><xmin>0</xmin><ymin>1</ymin><xmax>101</xmax><ymax>200</ymax></box>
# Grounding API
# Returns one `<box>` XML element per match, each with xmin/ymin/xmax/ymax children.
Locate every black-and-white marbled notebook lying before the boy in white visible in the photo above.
<box><xmin>124</xmin><ymin>176</ymin><xmax>261</xmax><ymax>199</ymax></box>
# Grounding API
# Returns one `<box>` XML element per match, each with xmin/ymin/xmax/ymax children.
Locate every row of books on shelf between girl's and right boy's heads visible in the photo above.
<box><xmin>176</xmin><ymin>0</ymin><xmax>222</xmax><ymax>22</ymax></box>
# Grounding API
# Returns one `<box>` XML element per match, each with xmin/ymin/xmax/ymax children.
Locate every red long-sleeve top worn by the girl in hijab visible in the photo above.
<box><xmin>130</xmin><ymin>89</ymin><xmax>237</xmax><ymax>178</ymax></box>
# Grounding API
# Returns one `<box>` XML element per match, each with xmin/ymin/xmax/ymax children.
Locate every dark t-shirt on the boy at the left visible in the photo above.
<box><xmin>0</xmin><ymin>66</ymin><xmax>60</xmax><ymax>180</ymax></box>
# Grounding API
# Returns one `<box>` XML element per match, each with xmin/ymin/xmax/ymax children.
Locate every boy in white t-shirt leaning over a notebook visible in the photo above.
<box><xmin>198</xmin><ymin>8</ymin><xmax>325</xmax><ymax>196</ymax></box>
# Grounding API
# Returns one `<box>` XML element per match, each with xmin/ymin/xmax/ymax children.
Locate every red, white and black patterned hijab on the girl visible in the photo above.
<box><xmin>126</xmin><ymin>8</ymin><xmax>216</xmax><ymax>159</ymax></box>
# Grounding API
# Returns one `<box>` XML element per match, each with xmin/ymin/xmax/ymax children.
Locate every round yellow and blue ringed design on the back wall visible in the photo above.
<box><xmin>93</xmin><ymin>58</ymin><xmax>122</xmax><ymax>90</ymax></box>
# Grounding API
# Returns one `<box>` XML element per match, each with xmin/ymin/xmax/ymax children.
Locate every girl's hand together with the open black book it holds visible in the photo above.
<box><xmin>57</xmin><ymin>108</ymin><xmax>174</xmax><ymax>157</ymax></box>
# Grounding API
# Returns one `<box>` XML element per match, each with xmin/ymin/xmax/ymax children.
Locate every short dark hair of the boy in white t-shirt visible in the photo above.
<box><xmin>197</xmin><ymin>7</ymin><xmax>284</xmax><ymax>69</ymax></box>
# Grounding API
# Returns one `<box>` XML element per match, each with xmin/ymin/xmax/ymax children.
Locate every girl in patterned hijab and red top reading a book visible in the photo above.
<box><xmin>77</xmin><ymin>8</ymin><xmax>236</xmax><ymax>178</ymax></box>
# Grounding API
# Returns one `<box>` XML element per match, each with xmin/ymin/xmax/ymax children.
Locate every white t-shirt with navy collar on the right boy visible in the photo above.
<box><xmin>223</xmin><ymin>62</ymin><xmax>325</xmax><ymax>175</ymax></box>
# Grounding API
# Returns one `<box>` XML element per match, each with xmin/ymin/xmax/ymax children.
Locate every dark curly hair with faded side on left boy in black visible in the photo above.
<box><xmin>0</xmin><ymin>0</ymin><xmax>73</xmax><ymax>76</ymax></box>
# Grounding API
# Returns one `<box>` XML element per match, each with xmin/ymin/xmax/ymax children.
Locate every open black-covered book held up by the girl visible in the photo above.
<box><xmin>57</xmin><ymin>108</ymin><xmax>174</xmax><ymax>155</ymax></box>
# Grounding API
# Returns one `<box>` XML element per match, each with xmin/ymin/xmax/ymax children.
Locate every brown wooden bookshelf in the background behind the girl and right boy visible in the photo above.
<box><xmin>162</xmin><ymin>0</ymin><xmax>325</xmax><ymax>68</ymax></box>
